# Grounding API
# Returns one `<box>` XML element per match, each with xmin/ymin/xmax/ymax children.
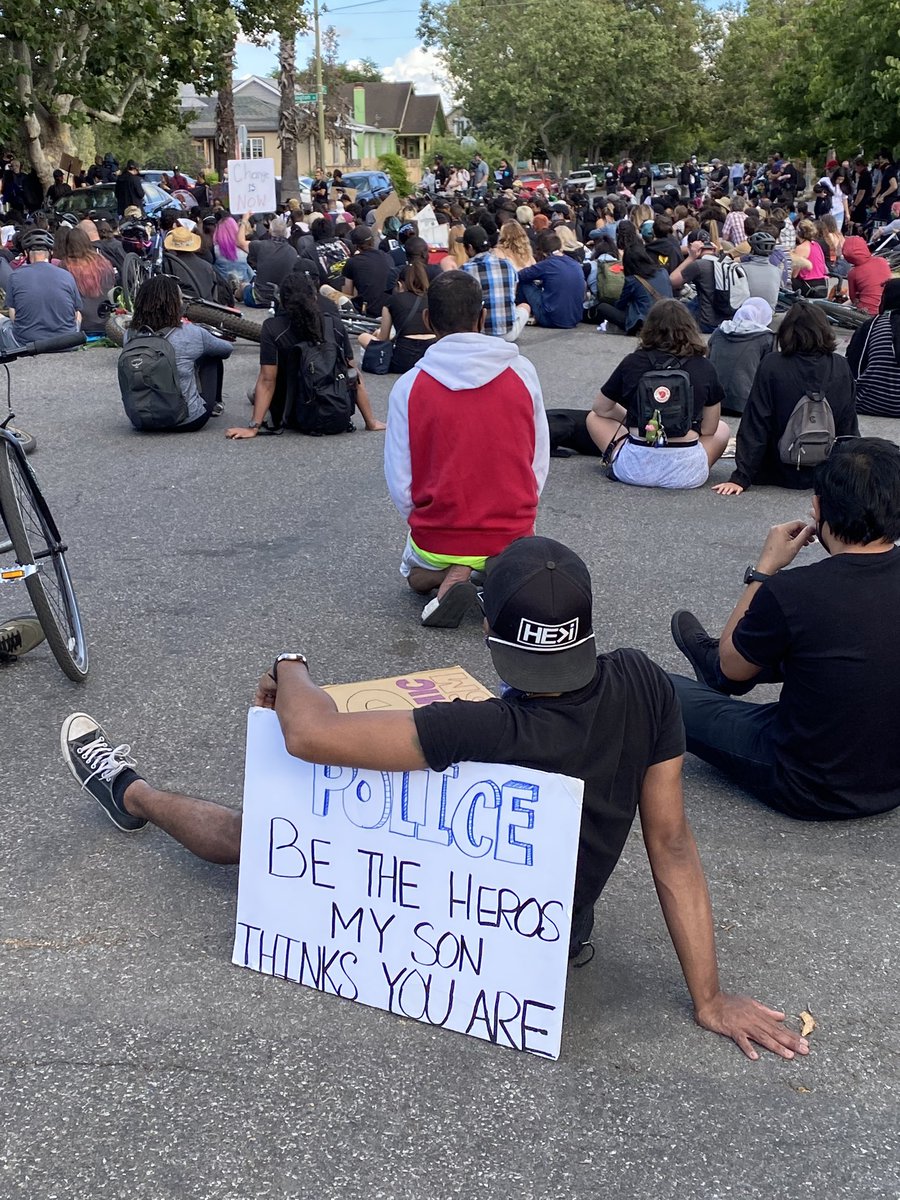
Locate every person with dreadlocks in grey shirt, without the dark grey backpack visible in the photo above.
<box><xmin>125</xmin><ymin>274</ymin><xmax>233</xmax><ymax>433</ymax></box>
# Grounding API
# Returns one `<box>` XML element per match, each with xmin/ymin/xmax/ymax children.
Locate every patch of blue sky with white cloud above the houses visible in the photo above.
<box><xmin>235</xmin><ymin>0</ymin><xmax>450</xmax><ymax>108</ymax></box>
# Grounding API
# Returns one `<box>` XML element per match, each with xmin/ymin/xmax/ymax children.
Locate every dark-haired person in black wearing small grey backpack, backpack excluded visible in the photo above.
<box><xmin>713</xmin><ymin>302</ymin><xmax>859</xmax><ymax>496</ymax></box>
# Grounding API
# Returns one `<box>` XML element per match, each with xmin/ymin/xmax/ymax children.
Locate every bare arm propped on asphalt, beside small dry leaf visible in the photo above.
<box><xmin>640</xmin><ymin>757</ymin><xmax>809</xmax><ymax>1058</ymax></box>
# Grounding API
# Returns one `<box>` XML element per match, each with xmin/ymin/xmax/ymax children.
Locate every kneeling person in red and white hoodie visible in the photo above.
<box><xmin>384</xmin><ymin>271</ymin><xmax>550</xmax><ymax>629</ymax></box>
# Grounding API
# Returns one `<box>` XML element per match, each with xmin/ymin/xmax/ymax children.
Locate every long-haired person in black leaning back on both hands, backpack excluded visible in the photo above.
<box><xmin>226</xmin><ymin>270</ymin><xmax>384</xmax><ymax>440</ymax></box>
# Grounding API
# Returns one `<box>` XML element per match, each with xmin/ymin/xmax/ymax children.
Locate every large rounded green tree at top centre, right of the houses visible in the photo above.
<box><xmin>420</xmin><ymin>0</ymin><xmax>704</xmax><ymax>162</ymax></box>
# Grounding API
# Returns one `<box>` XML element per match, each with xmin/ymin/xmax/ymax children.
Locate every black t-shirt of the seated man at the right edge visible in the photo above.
<box><xmin>732</xmin><ymin>550</ymin><xmax>900</xmax><ymax>818</ymax></box>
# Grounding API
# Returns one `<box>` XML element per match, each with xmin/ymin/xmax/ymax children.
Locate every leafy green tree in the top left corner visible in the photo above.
<box><xmin>0</xmin><ymin>0</ymin><xmax>235</xmax><ymax>186</ymax></box>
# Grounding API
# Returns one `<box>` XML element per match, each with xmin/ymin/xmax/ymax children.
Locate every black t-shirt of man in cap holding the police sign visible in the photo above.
<box><xmin>413</xmin><ymin>649</ymin><xmax>684</xmax><ymax>912</ymax></box>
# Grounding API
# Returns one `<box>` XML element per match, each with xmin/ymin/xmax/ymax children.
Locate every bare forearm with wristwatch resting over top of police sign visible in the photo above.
<box><xmin>254</xmin><ymin>662</ymin><xmax>428</xmax><ymax>770</ymax></box>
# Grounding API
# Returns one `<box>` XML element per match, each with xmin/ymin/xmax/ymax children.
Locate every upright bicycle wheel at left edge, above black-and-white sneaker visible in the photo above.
<box><xmin>0</xmin><ymin>438</ymin><xmax>89</xmax><ymax>683</ymax></box>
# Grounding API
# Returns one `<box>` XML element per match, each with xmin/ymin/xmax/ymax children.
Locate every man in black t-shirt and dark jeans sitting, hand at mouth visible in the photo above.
<box><xmin>672</xmin><ymin>438</ymin><xmax>900</xmax><ymax>821</ymax></box>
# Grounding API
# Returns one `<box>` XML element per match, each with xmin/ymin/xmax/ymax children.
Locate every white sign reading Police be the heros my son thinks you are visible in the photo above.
<box><xmin>233</xmin><ymin>708</ymin><xmax>583</xmax><ymax>1058</ymax></box>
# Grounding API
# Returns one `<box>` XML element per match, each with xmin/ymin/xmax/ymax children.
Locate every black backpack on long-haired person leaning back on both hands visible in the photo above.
<box><xmin>283</xmin><ymin>317</ymin><xmax>354</xmax><ymax>437</ymax></box>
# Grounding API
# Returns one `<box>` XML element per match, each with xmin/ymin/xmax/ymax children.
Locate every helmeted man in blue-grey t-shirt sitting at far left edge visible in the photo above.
<box><xmin>0</xmin><ymin>228</ymin><xmax>83</xmax><ymax>350</ymax></box>
